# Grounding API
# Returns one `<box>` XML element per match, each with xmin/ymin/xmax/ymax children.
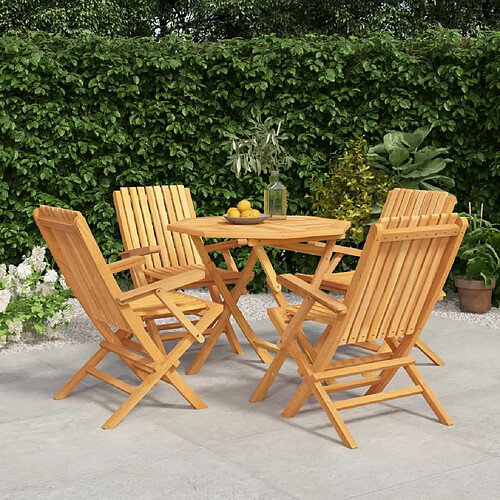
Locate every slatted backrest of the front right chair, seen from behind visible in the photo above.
<box><xmin>339</xmin><ymin>214</ymin><xmax>467</xmax><ymax>344</ymax></box>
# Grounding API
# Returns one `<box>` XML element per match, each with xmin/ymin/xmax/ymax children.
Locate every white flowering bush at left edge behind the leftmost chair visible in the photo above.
<box><xmin>0</xmin><ymin>247</ymin><xmax>74</xmax><ymax>343</ymax></box>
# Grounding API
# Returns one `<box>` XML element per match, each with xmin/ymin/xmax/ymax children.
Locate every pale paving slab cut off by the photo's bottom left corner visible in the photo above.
<box><xmin>3</xmin><ymin>450</ymin><xmax>295</xmax><ymax>500</ymax></box>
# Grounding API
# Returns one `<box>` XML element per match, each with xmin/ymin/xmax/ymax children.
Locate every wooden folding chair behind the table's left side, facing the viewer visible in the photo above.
<box><xmin>113</xmin><ymin>186</ymin><xmax>247</xmax><ymax>374</ymax></box>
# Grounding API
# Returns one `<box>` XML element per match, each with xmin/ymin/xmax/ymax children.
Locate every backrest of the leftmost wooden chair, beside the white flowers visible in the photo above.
<box><xmin>33</xmin><ymin>206</ymin><xmax>129</xmax><ymax>330</ymax></box>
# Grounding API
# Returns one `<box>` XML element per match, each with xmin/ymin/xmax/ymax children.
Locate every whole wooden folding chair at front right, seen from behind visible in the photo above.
<box><xmin>250</xmin><ymin>214</ymin><xmax>467</xmax><ymax>448</ymax></box>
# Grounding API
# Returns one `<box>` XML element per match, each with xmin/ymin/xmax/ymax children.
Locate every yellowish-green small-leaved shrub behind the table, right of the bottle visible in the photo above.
<box><xmin>312</xmin><ymin>139</ymin><xmax>392</xmax><ymax>244</ymax></box>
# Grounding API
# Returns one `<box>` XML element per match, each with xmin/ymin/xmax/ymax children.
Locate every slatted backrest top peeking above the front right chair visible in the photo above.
<box><xmin>380</xmin><ymin>188</ymin><xmax>457</xmax><ymax>219</ymax></box>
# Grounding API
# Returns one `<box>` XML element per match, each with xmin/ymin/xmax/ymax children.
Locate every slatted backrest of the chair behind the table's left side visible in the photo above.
<box><xmin>113</xmin><ymin>186</ymin><xmax>202</xmax><ymax>269</ymax></box>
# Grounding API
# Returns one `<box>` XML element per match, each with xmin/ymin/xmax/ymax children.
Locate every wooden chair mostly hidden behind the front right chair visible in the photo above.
<box><xmin>297</xmin><ymin>188</ymin><xmax>457</xmax><ymax>366</ymax></box>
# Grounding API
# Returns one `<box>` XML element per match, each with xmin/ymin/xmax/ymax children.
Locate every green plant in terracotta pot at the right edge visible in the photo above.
<box><xmin>455</xmin><ymin>214</ymin><xmax>500</xmax><ymax>313</ymax></box>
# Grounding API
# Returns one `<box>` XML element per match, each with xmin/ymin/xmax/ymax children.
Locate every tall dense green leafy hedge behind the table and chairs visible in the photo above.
<box><xmin>0</xmin><ymin>30</ymin><xmax>500</xmax><ymax>290</ymax></box>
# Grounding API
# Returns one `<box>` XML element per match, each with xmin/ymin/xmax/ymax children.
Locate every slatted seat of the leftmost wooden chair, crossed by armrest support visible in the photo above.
<box><xmin>129</xmin><ymin>292</ymin><xmax>215</xmax><ymax>317</ymax></box>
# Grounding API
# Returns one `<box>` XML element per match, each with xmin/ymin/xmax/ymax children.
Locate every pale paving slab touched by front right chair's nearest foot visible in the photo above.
<box><xmin>209</xmin><ymin>414</ymin><xmax>491</xmax><ymax>500</ymax></box>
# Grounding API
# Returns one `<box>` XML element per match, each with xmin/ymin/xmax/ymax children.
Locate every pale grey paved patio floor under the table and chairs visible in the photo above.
<box><xmin>0</xmin><ymin>317</ymin><xmax>500</xmax><ymax>499</ymax></box>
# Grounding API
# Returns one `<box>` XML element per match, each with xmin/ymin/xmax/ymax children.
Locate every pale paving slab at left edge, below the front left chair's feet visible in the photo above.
<box><xmin>0</xmin><ymin>407</ymin><xmax>195</xmax><ymax>497</ymax></box>
